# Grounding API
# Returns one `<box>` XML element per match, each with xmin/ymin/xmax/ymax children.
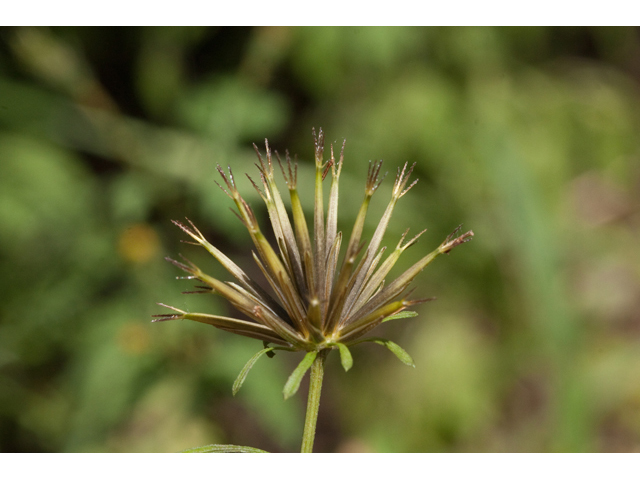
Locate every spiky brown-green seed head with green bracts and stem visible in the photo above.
<box><xmin>154</xmin><ymin>130</ymin><xmax>473</xmax><ymax>452</ymax></box>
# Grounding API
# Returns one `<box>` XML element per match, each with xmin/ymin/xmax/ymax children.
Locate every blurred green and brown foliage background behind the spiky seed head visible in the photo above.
<box><xmin>0</xmin><ymin>27</ymin><xmax>640</xmax><ymax>452</ymax></box>
